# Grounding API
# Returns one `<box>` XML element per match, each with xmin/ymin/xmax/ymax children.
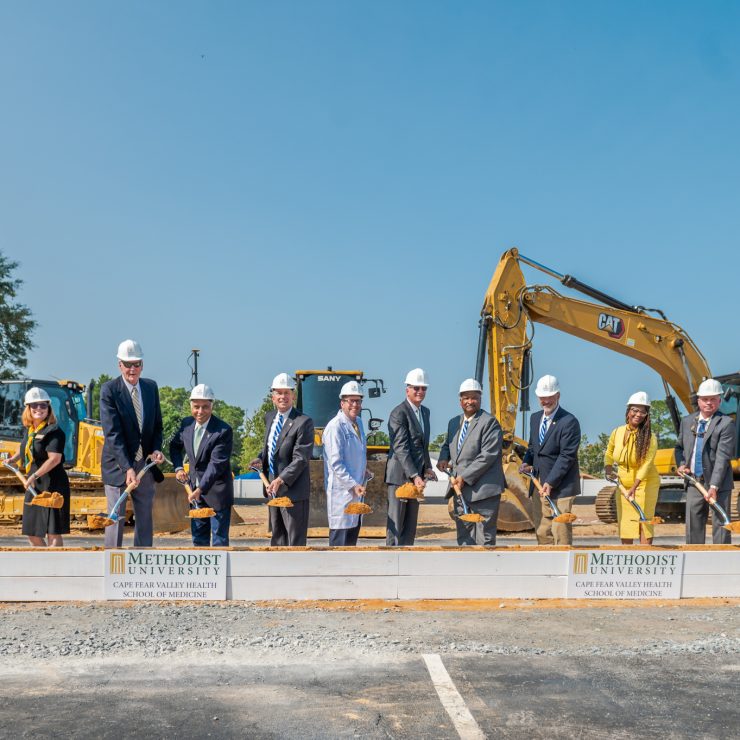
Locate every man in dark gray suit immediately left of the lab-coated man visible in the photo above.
<box><xmin>250</xmin><ymin>373</ymin><xmax>314</xmax><ymax>547</ymax></box>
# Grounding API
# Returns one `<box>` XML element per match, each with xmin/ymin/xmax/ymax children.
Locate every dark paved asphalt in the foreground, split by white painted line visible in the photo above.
<box><xmin>0</xmin><ymin>654</ymin><xmax>740</xmax><ymax>740</ymax></box>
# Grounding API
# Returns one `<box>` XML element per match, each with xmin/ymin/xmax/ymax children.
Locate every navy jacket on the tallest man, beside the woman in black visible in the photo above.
<box><xmin>100</xmin><ymin>375</ymin><xmax>163</xmax><ymax>486</ymax></box>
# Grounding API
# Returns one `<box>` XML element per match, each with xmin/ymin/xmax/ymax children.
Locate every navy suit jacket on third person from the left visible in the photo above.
<box><xmin>170</xmin><ymin>415</ymin><xmax>234</xmax><ymax>511</ymax></box>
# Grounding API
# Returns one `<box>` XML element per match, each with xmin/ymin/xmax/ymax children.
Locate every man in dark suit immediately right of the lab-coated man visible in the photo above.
<box><xmin>385</xmin><ymin>368</ymin><xmax>437</xmax><ymax>547</ymax></box>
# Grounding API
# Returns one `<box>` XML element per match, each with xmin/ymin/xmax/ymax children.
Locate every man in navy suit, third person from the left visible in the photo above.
<box><xmin>170</xmin><ymin>383</ymin><xmax>234</xmax><ymax>547</ymax></box>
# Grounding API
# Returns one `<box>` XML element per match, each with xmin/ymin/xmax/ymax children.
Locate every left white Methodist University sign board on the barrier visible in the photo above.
<box><xmin>105</xmin><ymin>550</ymin><xmax>228</xmax><ymax>601</ymax></box>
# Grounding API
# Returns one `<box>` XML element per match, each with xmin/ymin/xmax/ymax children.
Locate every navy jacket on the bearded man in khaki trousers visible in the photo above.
<box><xmin>523</xmin><ymin>406</ymin><xmax>581</xmax><ymax>499</ymax></box>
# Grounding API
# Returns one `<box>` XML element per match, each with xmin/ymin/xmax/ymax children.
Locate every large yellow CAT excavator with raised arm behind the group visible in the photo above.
<box><xmin>475</xmin><ymin>249</ymin><xmax>740</xmax><ymax>531</ymax></box>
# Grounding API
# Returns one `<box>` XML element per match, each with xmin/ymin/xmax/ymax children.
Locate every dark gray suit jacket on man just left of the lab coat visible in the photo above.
<box><xmin>258</xmin><ymin>407</ymin><xmax>314</xmax><ymax>501</ymax></box>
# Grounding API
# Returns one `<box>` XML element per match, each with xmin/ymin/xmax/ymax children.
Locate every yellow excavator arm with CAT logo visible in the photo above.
<box><xmin>476</xmin><ymin>249</ymin><xmax>711</xmax><ymax>440</ymax></box>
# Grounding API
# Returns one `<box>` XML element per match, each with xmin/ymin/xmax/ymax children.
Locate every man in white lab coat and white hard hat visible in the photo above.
<box><xmin>323</xmin><ymin>380</ymin><xmax>368</xmax><ymax>547</ymax></box>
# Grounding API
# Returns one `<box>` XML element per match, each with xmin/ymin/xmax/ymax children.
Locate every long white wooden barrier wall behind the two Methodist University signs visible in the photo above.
<box><xmin>0</xmin><ymin>547</ymin><xmax>740</xmax><ymax>601</ymax></box>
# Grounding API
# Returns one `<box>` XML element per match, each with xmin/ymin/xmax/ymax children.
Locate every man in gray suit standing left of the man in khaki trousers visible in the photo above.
<box><xmin>437</xmin><ymin>378</ymin><xmax>506</xmax><ymax>547</ymax></box>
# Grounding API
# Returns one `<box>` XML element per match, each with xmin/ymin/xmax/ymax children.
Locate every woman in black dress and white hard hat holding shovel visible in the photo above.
<box><xmin>10</xmin><ymin>388</ymin><xmax>70</xmax><ymax>547</ymax></box>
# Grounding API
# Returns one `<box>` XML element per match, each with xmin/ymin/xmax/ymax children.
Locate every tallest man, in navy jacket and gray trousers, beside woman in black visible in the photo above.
<box><xmin>100</xmin><ymin>339</ymin><xmax>164</xmax><ymax>547</ymax></box>
